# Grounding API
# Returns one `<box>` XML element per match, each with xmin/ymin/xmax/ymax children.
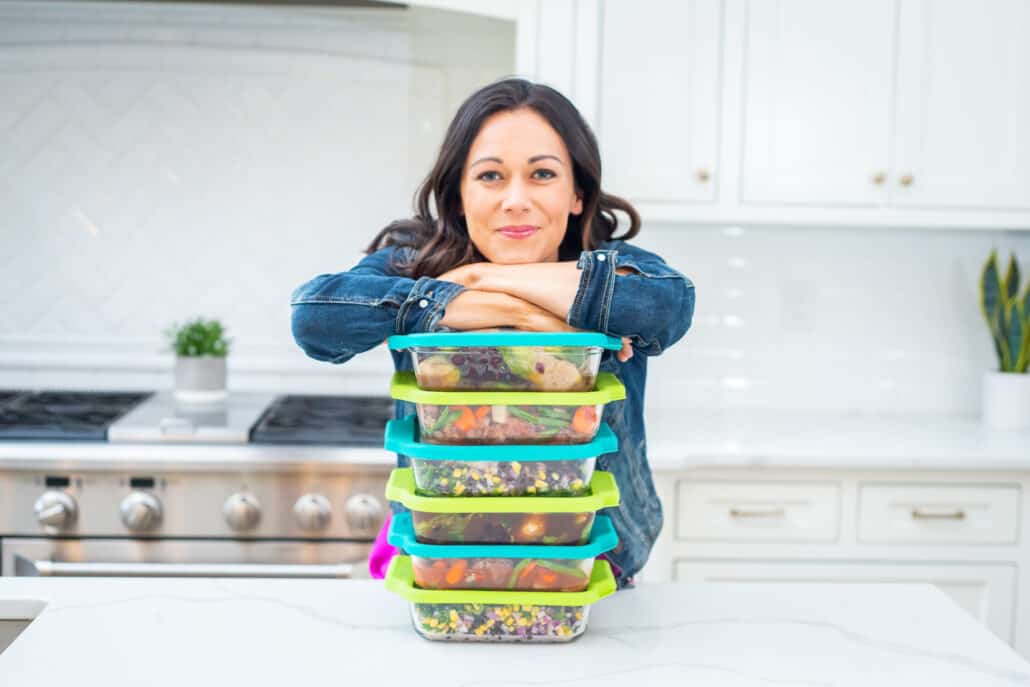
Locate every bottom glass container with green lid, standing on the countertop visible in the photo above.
<box><xmin>386</xmin><ymin>556</ymin><xmax>615</xmax><ymax>642</ymax></box>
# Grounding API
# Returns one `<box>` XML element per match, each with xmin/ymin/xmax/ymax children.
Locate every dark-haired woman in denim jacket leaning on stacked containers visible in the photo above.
<box><xmin>293</xmin><ymin>78</ymin><xmax>694</xmax><ymax>588</ymax></box>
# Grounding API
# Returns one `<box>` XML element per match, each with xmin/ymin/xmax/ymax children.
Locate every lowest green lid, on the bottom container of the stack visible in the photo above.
<box><xmin>385</xmin><ymin>556</ymin><xmax>615</xmax><ymax>606</ymax></box>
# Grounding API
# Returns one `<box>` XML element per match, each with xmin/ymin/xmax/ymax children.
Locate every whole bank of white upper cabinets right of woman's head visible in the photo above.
<box><xmin>517</xmin><ymin>0</ymin><xmax>1030</xmax><ymax>230</ymax></box>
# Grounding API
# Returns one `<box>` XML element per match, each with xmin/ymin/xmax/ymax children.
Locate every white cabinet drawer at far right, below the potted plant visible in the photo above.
<box><xmin>858</xmin><ymin>484</ymin><xmax>1020</xmax><ymax>544</ymax></box>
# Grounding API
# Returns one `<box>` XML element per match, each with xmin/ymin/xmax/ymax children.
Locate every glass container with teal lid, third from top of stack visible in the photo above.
<box><xmin>384</xmin><ymin>415</ymin><xmax>619</xmax><ymax>496</ymax></box>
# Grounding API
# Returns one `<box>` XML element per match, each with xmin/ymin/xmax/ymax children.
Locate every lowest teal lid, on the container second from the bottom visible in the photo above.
<box><xmin>386</xmin><ymin>513</ymin><xmax>619</xmax><ymax>560</ymax></box>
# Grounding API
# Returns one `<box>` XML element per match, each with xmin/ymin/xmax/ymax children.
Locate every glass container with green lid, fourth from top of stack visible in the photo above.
<box><xmin>386</xmin><ymin>468</ymin><xmax>619</xmax><ymax>544</ymax></box>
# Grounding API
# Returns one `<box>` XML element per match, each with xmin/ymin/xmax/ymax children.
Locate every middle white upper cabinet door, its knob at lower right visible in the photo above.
<box><xmin>741</xmin><ymin>0</ymin><xmax>896</xmax><ymax>206</ymax></box>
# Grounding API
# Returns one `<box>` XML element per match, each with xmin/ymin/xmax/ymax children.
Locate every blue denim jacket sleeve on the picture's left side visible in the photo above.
<box><xmin>290</xmin><ymin>248</ymin><xmax>464</xmax><ymax>364</ymax></box>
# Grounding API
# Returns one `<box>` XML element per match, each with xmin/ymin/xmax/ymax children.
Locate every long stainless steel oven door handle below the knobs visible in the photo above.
<box><xmin>14</xmin><ymin>555</ymin><xmax>354</xmax><ymax>579</ymax></box>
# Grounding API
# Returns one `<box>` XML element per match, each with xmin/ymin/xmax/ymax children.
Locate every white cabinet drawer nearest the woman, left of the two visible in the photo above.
<box><xmin>677</xmin><ymin>481</ymin><xmax>840</xmax><ymax>542</ymax></box>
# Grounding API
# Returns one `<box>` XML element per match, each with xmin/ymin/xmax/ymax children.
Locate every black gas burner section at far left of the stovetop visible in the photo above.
<box><xmin>0</xmin><ymin>390</ymin><xmax>150</xmax><ymax>441</ymax></box>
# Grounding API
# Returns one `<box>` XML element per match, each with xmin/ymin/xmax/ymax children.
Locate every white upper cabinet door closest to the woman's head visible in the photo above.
<box><xmin>598</xmin><ymin>0</ymin><xmax>722</xmax><ymax>203</ymax></box>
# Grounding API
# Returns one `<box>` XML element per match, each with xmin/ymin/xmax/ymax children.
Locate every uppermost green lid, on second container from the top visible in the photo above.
<box><xmin>389</xmin><ymin>371</ymin><xmax>626</xmax><ymax>406</ymax></box>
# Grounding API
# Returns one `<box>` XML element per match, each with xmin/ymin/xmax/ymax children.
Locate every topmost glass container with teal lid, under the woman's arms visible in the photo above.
<box><xmin>388</xmin><ymin>332</ymin><xmax>622</xmax><ymax>391</ymax></box>
